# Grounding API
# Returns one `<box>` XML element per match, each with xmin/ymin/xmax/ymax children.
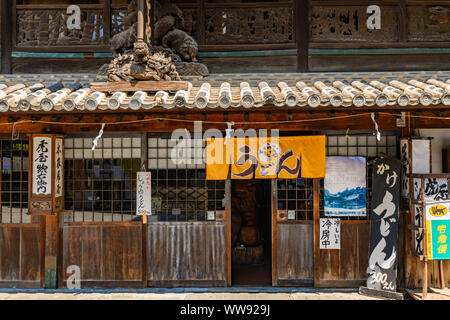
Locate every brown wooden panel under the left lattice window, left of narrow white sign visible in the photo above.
<box><xmin>63</xmin><ymin>224</ymin><xmax>142</xmax><ymax>287</ymax></box>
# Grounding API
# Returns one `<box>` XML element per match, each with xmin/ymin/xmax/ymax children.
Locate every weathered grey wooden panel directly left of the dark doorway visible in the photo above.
<box><xmin>147</xmin><ymin>222</ymin><xmax>226</xmax><ymax>286</ymax></box>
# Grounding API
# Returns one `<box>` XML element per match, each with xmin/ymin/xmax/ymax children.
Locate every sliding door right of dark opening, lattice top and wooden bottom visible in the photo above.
<box><xmin>272</xmin><ymin>179</ymin><xmax>314</xmax><ymax>286</ymax></box>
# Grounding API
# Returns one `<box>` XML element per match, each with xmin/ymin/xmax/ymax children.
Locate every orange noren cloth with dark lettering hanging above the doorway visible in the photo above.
<box><xmin>206</xmin><ymin>136</ymin><xmax>325</xmax><ymax>180</ymax></box>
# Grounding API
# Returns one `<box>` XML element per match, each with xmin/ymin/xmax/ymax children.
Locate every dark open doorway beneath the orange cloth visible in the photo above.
<box><xmin>231</xmin><ymin>179</ymin><xmax>272</xmax><ymax>286</ymax></box>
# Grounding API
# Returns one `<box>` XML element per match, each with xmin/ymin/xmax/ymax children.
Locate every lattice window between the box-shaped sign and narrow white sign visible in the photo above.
<box><xmin>64</xmin><ymin>135</ymin><xmax>141</xmax><ymax>222</ymax></box>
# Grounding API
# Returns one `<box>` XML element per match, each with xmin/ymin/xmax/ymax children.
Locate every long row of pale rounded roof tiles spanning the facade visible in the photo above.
<box><xmin>0</xmin><ymin>71</ymin><xmax>450</xmax><ymax>112</ymax></box>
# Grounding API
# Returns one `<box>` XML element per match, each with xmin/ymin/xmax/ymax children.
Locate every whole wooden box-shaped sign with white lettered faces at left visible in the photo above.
<box><xmin>28</xmin><ymin>134</ymin><xmax>64</xmax><ymax>215</ymax></box>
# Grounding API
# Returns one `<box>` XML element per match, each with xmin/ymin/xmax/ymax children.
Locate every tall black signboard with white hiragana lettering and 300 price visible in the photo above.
<box><xmin>367</xmin><ymin>158</ymin><xmax>401</xmax><ymax>291</ymax></box>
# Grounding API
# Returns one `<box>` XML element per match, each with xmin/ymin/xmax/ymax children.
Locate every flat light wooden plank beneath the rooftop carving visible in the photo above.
<box><xmin>91</xmin><ymin>81</ymin><xmax>189</xmax><ymax>92</ymax></box>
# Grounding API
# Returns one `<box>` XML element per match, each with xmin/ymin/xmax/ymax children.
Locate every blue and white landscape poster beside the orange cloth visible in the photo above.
<box><xmin>324</xmin><ymin>156</ymin><xmax>367</xmax><ymax>217</ymax></box>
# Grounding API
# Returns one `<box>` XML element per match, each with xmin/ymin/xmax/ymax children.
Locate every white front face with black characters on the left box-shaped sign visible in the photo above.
<box><xmin>32</xmin><ymin>137</ymin><xmax>52</xmax><ymax>195</ymax></box>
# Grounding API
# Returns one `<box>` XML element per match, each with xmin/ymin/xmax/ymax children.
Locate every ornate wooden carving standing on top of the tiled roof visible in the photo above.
<box><xmin>98</xmin><ymin>0</ymin><xmax>209</xmax><ymax>82</ymax></box>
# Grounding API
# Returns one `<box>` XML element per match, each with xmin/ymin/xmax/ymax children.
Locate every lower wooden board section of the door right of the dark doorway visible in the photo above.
<box><xmin>277</xmin><ymin>223</ymin><xmax>314</xmax><ymax>284</ymax></box>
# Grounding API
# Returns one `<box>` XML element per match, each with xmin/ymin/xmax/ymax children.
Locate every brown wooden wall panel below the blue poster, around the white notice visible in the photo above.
<box><xmin>315</xmin><ymin>221</ymin><xmax>370</xmax><ymax>287</ymax></box>
